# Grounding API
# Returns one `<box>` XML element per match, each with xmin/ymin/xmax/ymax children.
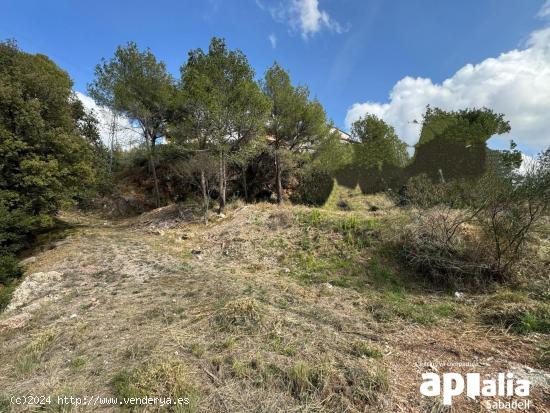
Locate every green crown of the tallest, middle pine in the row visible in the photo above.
<box><xmin>176</xmin><ymin>37</ymin><xmax>269</xmax><ymax>150</ymax></box>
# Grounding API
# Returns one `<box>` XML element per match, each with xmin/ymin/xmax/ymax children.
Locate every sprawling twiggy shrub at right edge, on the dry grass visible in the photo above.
<box><xmin>401</xmin><ymin>149</ymin><xmax>550</xmax><ymax>284</ymax></box>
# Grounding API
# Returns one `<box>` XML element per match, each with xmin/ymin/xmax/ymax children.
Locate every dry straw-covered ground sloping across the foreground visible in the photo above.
<box><xmin>0</xmin><ymin>204</ymin><xmax>550</xmax><ymax>412</ymax></box>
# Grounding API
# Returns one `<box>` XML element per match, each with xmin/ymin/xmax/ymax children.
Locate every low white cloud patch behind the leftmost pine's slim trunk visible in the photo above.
<box><xmin>76</xmin><ymin>92</ymin><xmax>141</xmax><ymax>148</ymax></box>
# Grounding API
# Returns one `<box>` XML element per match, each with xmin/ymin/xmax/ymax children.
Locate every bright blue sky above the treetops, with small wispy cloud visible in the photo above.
<box><xmin>0</xmin><ymin>0</ymin><xmax>550</xmax><ymax>152</ymax></box>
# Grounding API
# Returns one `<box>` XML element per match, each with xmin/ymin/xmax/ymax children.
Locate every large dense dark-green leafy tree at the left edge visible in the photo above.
<box><xmin>0</xmin><ymin>42</ymin><xmax>99</xmax><ymax>281</ymax></box>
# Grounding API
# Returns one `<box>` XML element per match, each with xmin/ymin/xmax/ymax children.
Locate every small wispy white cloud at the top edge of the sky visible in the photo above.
<box><xmin>256</xmin><ymin>0</ymin><xmax>346</xmax><ymax>40</ymax></box>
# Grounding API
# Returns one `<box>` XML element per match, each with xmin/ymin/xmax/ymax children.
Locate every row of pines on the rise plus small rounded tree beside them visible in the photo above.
<box><xmin>89</xmin><ymin>38</ymin><xmax>414</xmax><ymax>216</ymax></box>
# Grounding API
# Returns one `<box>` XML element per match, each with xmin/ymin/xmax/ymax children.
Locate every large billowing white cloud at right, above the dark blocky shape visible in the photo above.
<box><xmin>345</xmin><ymin>25</ymin><xmax>550</xmax><ymax>152</ymax></box>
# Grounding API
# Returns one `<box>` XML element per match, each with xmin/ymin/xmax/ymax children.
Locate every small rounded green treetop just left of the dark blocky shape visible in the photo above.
<box><xmin>351</xmin><ymin>114</ymin><xmax>409</xmax><ymax>169</ymax></box>
